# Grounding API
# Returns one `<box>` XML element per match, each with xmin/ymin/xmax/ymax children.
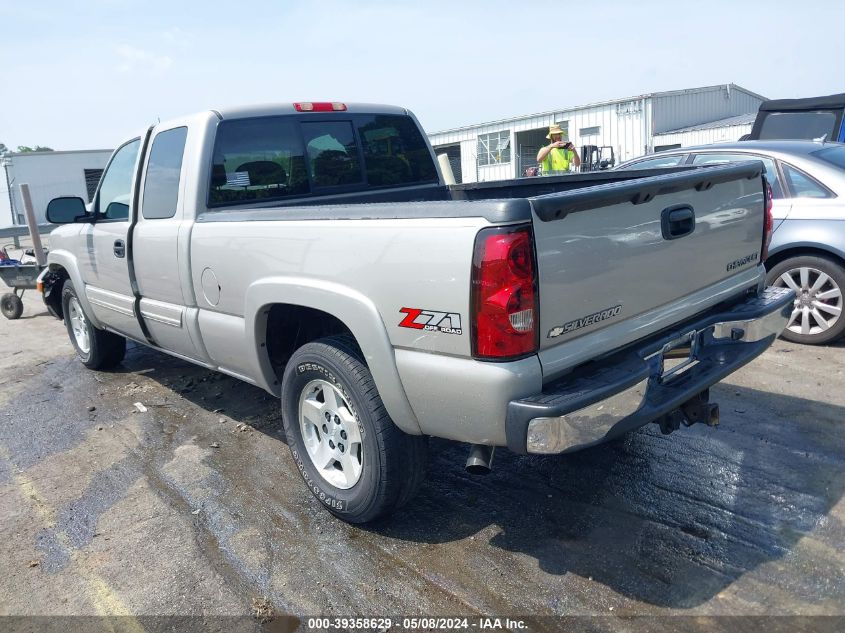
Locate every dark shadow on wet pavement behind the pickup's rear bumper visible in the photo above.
<box><xmin>376</xmin><ymin>387</ymin><xmax>845</xmax><ymax>608</ymax></box>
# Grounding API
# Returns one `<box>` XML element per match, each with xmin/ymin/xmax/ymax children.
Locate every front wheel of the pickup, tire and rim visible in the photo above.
<box><xmin>62</xmin><ymin>280</ymin><xmax>126</xmax><ymax>369</ymax></box>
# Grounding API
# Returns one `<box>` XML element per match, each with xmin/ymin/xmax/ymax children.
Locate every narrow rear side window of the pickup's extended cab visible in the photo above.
<box><xmin>141</xmin><ymin>127</ymin><xmax>188</xmax><ymax>220</ymax></box>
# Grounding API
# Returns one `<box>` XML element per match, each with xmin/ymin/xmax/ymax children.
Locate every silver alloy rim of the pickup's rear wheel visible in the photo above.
<box><xmin>299</xmin><ymin>380</ymin><xmax>364</xmax><ymax>490</ymax></box>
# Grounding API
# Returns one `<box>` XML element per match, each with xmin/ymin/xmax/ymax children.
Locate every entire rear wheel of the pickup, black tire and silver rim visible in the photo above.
<box><xmin>282</xmin><ymin>337</ymin><xmax>426</xmax><ymax>523</ymax></box>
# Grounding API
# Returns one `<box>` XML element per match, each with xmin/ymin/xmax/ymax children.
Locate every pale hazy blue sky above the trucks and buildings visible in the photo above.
<box><xmin>0</xmin><ymin>0</ymin><xmax>845</xmax><ymax>150</ymax></box>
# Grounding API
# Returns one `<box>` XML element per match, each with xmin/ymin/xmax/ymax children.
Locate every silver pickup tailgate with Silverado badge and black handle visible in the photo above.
<box><xmin>530</xmin><ymin>161</ymin><xmax>765</xmax><ymax>377</ymax></box>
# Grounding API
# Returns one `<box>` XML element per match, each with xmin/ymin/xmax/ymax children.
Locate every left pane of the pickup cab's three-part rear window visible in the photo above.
<box><xmin>208</xmin><ymin>117</ymin><xmax>309</xmax><ymax>206</ymax></box>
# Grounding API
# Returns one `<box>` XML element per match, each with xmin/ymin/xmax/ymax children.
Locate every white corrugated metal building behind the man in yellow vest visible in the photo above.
<box><xmin>429</xmin><ymin>84</ymin><xmax>765</xmax><ymax>182</ymax></box>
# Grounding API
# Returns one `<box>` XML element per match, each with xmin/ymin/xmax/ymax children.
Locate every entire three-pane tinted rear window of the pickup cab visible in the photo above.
<box><xmin>208</xmin><ymin>114</ymin><xmax>437</xmax><ymax>207</ymax></box>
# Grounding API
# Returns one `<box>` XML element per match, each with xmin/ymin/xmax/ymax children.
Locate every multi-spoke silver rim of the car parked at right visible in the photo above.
<box><xmin>773</xmin><ymin>266</ymin><xmax>842</xmax><ymax>336</ymax></box>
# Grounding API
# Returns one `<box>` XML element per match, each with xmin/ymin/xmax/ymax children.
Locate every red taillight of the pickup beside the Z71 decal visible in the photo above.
<box><xmin>472</xmin><ymin>226</ymin><xmax>539</xmax><ymax>360</ymax></box>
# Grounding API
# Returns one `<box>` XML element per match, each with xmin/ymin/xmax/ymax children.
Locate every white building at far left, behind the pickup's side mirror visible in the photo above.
<box><xmin>0</xmin><ymin>149</ymin><xmax>112</xmax><ymax>226</ymax></box>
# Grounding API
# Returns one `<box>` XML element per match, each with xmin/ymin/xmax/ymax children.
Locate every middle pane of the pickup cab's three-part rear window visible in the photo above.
<box><xmin>302</xmin><ymin>121</ymin><xmax>364</xmax><ymax>187</ymax></box>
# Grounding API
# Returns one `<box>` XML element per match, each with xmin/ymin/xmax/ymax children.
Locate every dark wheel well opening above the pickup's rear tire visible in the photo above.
<box><xmin>265</xmin><ymin>304</ymin><xmax>360</xmax><ymax>378</ymax></box>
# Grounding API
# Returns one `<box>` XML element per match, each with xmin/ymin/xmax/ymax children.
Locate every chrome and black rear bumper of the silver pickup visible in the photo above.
<box><xmin>506</xmin><ymin>288</ymin><xmax>794</xmax><ymax>453</ymax></box>
